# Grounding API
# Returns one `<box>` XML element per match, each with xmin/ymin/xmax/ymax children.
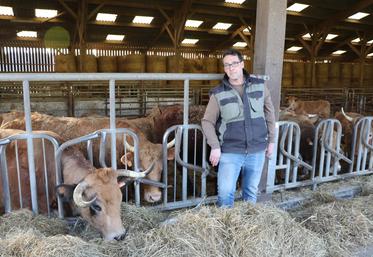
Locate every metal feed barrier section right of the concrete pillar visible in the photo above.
<box><xmin>267</xmin><ymin>117</ymin><xmax>373</xmax><ymax>193</ymax></box>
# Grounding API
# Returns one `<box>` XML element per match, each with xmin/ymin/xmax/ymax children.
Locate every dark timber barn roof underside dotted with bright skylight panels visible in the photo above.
<box><xmin>0</xmin><ymin>0</ymin><xmax>373</xmax><ymax>60</ymax></box>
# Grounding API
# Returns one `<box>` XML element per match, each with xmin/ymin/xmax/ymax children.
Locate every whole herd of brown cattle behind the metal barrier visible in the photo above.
<box><xmin>0</xmin><ymin>97</ymin><xmax>370</xmax><ymax>240</ymax></box>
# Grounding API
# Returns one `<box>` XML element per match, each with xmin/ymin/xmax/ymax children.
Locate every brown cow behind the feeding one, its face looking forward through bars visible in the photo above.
<box><xmin>3</xmin><ymin>113</ymin><xmax>174</xmax><ymax>202</ymax></box>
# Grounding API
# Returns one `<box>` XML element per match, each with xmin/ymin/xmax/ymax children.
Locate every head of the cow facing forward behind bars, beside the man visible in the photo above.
<box><xmin>121</xmin><ymin>140</ymin><xmax>175</xmax><ymax>203</ymax></box>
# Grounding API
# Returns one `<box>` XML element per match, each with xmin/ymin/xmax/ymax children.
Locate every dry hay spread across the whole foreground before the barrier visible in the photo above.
<box><xmin>0</xmin><ymin>177</ymin><xmax>373</xmax><ymax>257</ymax></box>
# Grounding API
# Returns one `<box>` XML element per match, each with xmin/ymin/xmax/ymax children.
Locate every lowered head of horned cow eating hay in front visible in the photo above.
<box><xmin>57</xmin><ymin>168</ymin><xmax>146</xmax><ymax>240</ymax></box>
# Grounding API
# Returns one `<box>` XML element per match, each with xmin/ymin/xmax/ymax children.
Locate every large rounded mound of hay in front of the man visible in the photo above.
<box><xmin>124</xmin><ymin>204</ymin><xmax>327</xmax><ymax>257</ymax></box>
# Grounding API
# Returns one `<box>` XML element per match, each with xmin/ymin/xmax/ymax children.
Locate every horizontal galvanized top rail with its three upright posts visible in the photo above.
<box><xmin>0</xmin><ymin>73</ymin><xmax>222</xmax><ymax>213</ymax></box>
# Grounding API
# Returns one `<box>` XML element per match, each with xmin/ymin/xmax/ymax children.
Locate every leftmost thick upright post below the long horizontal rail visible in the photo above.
<box><xmin>23</xmin><ymin>80</ymin><xmax>39</xmax><ymax>214</ymax></box>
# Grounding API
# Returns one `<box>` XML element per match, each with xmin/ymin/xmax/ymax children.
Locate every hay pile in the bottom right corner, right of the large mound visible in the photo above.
<box><xmin>292</xmin><ymin>196</ymin><xmax>373</xmax><ymax>257</ymax></box>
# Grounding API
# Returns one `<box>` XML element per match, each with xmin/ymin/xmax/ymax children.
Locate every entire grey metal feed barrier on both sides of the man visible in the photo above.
<box><xmin>0</xmin><ymin>73</ymin><xmax>373</xmax><ymax>216</ymax></box>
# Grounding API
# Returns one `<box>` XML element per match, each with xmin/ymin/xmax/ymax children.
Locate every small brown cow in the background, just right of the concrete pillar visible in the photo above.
<box><xmin>287</xmin><ymin>96</ymin><xmax>330</xmax><ymax>119</ymax></box>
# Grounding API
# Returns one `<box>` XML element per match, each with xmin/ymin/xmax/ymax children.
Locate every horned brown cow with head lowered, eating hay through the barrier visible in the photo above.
<box><xmin>0</xmin><ymin>129</ymin><xmax>147</xmax><ymax>240</ymax></box>
